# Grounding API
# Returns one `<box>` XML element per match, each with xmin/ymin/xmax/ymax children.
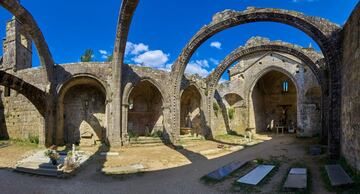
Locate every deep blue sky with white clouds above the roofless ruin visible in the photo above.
<box><xmin>0</xmin><ymin>0</ymin><xmax>358</xmax><ymax>79</ymax></box>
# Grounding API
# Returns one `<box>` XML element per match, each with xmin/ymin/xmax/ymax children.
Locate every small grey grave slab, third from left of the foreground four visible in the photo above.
<box><xmin>284</xmin><ymin>168</ymin><xmax>307</xmax><ymax>189</ymax></box>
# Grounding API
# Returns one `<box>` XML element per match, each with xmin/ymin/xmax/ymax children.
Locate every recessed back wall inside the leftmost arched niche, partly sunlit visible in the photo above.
<box><xmin>63</xmin><ymin>84</ymin><xmax>106</xmax><ymax>145</ymax></box>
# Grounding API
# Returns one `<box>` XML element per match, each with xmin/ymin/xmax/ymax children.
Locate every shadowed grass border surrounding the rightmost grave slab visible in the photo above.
<box><xmin>320</xmin><ymin>158</ymin><xmax>360</xmax><ymax>193</ymax></box>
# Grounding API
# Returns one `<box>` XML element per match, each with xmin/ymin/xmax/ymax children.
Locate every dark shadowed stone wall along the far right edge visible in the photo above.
<box><xmin>341</xmin><ymin>4</ymin><xmax>360</xmax><ymax>170</ymax></box>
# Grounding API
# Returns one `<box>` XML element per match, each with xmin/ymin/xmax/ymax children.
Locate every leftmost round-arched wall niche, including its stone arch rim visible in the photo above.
<box><xmin>56</xmin><ymin>76</ymin><xmax>107</xmax><ymax>146</ymax></box>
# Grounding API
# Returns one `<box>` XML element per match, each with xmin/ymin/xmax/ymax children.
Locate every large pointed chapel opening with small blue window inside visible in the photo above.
<box><xmin>249</xmin><ymin>70</ymin><xmax>298</xmax><ymax>133</ymax></box>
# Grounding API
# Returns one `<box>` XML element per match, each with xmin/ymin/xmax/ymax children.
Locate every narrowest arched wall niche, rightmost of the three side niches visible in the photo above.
<box><xmin>180</xmin><ymin>85</ymin><xmax>203</xmax><ymax>136</ymax></box>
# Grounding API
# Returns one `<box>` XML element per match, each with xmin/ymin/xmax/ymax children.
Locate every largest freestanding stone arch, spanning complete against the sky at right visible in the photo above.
<box><xmin>171</xmin><ymin>7</ymin><xmax>341</xmax><ymax>157</ymax></box>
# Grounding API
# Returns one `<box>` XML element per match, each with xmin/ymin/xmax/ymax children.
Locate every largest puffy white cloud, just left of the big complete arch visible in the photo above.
<box><xmin>132</xmin><ymin>50</ymin><xmax>169</xmax><ymax>68</ymax></box>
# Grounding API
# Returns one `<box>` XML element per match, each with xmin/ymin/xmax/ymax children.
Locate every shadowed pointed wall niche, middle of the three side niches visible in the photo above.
<box><xmin>127</xmin><ymin>80</ymin><xmax>164</xmax><ymax>138</ymax></box>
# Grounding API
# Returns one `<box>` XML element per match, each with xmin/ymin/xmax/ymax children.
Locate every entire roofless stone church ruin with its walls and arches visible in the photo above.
<box><xmin>0</xmin><ymin>0</ymin><xmax>360</xmax><ymax>174</ymax></box>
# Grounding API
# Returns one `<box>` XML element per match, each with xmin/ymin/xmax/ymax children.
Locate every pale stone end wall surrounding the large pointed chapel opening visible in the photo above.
<box><xmin>211</xmin><ymin>52</ymin><xmax>321</xmax><ymax>136</ymax></box>
